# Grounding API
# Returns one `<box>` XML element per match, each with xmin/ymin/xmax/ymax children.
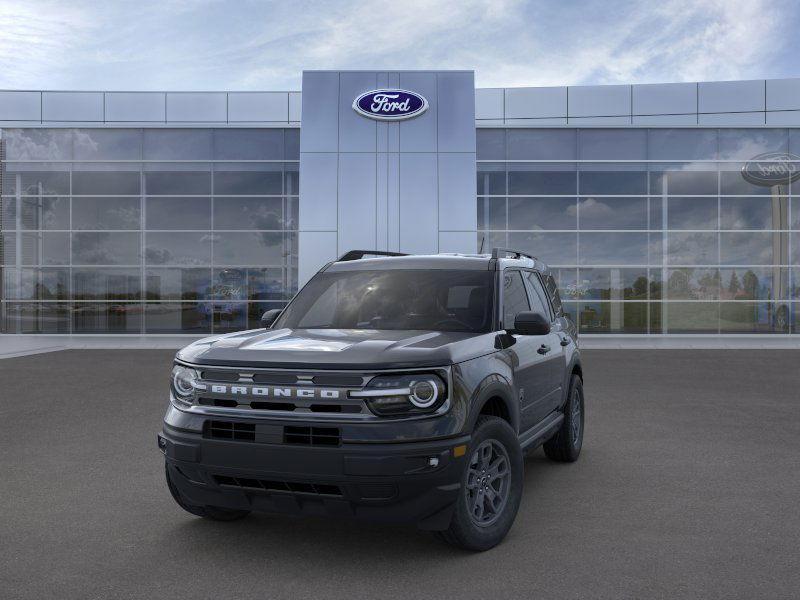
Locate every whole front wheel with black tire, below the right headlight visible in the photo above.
<box><xmin>436</xmin><ymin>416</ymin><xmax>523</xmax><ymax>552</ymax></box>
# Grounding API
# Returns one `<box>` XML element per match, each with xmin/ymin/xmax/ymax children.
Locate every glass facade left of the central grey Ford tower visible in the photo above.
<box><xmin>0</xmin><ymin>128</ymin><xmax>299</xmax><ymax>334</ymax></box>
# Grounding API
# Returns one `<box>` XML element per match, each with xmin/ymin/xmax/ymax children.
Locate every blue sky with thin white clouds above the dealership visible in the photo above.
<box><xmin>0</xmin><ymin>0</ymin><xmax>800</xmax><ymax>90</ymax></box>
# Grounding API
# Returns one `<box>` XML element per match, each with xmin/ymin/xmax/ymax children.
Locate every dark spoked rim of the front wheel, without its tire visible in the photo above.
<box><xmin>464</xmin><ymin>440</ymin><xmax>511</xmax><ymax>527</ymax></box>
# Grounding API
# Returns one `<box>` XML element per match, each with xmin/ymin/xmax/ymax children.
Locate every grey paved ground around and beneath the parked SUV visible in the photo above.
<box><xmin>0</xmin><ymin>350</ymin><xmax>800</xmax><ymax>600</ymax></box>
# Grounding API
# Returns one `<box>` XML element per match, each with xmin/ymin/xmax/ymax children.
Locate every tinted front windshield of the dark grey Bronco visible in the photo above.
<box><xmin>273</xmin><ymin>270</ymin><xmax>494</xmax><ymax>333</ymax></box>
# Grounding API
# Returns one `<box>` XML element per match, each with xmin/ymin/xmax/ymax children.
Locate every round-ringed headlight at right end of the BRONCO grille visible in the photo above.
<box><xmin>350</xmin><ymin>373</ymin><xmax>447</xmax><ymax>416</ymax></box>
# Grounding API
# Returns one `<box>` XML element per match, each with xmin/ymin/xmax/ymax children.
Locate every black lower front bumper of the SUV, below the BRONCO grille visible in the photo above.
<box><xmin>158</xmin><ymin>423</ymin><xmax>469</xmax><ymax>530</ymax></box>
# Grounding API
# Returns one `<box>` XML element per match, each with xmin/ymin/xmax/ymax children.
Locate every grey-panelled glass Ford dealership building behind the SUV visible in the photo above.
<box><xmin>0</xmin><ymin>71</ymin><xmax>800</xmax><ymax>339</ymax></box>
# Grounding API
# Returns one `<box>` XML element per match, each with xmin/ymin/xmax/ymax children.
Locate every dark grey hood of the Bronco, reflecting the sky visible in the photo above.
<box><xmin>177</xmin><ymin>329</ymin><xmax>495</xmax><ymax>370</ymax></box>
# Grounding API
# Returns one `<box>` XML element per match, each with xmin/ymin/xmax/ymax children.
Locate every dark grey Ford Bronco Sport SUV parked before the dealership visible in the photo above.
<box><xmin>158</xmin><ymin>248</ymin><xmax>584</xmax><ymax>550</ymax></box>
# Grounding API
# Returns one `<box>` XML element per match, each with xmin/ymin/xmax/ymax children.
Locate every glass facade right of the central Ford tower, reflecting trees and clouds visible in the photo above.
<box><xmin>477</xmin><ymin>128</ymin><xmax>800</xmax><ymax>334</ymax></box>
